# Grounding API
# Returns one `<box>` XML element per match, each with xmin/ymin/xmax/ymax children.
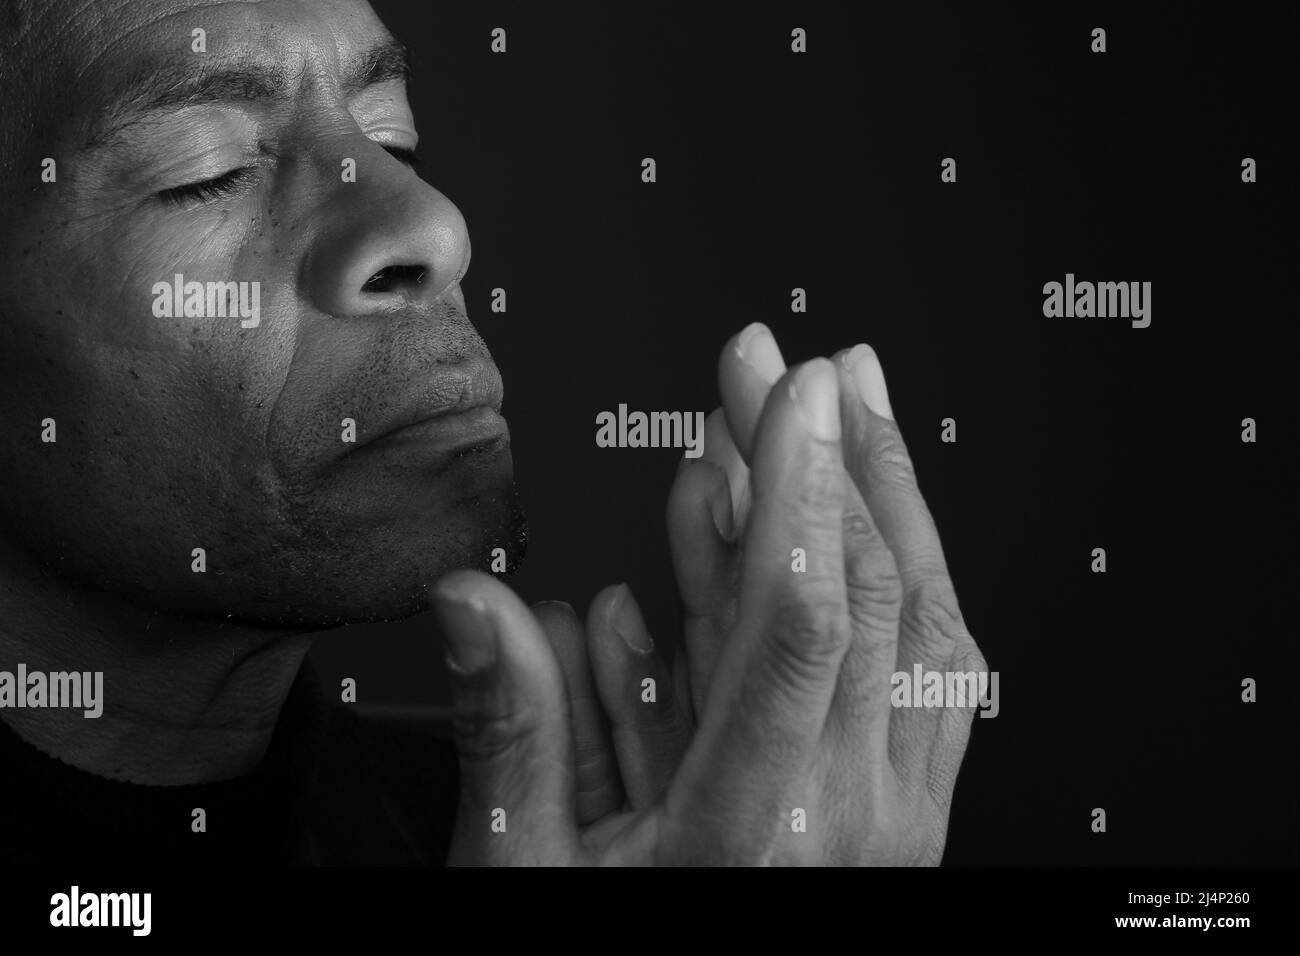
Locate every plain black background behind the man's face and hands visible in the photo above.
<box><xmin>306</xmin><ymin>0</ymin><xmax>1300</xmax><ymax>865</ymax></box>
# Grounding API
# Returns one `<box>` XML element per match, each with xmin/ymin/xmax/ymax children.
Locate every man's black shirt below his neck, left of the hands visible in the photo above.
<box><xmin>0</xmin><ymin>663</ymin><xmax>458</xmax><ymax>866</ymax></box>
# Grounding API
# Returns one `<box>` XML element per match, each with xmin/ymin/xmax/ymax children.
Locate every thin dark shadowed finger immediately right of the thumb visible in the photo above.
<box><xmin>533</xmin><ymin>601</ymin><xmax>624</xmax><ymax>826</ymax></box>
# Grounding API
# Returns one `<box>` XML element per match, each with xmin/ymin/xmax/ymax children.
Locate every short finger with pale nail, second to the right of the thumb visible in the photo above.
<box><xmin>586</xmin><ymin>584</ymin><xmax>692</xmax><ymax>810</ymax></box>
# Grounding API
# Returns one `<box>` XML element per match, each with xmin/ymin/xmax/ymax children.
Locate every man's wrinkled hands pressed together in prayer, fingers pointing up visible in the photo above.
<box><xmin>438</xmin><ymin>325</ymin><xmax>987</xmax><ymax>865</ymax></box>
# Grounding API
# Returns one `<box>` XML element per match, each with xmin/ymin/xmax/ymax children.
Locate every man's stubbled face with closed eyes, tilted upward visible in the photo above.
<box><xmin>0</xmin><ymin>0</ymin><xmax>521</xmax><ymax>627</ymax></box>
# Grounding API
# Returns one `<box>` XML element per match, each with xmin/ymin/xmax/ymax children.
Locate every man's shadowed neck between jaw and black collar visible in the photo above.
<box><xmin>0</xmin><ymin>538</ymin><xmax>312</xmax><ymax>786</ymax></box>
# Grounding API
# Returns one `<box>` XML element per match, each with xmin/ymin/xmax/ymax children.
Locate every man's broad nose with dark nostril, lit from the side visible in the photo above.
<box><xmin>306</xmin><ymin>142</ymin><xmax>469</xmax><ymax>319</ymax></box>
